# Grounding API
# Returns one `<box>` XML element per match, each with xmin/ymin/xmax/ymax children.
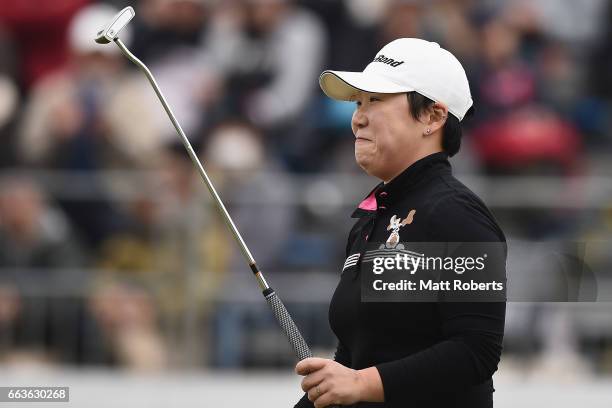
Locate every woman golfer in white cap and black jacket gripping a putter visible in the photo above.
<box><xmin>296</xmin><ymin>38</ymin><xmax>505</xmax><ymax>408</ymax></box>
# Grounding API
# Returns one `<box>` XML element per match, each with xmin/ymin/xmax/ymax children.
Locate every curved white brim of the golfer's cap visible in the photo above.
<box><xmin>319</xmin><ymin>70</ymin><xmax>414</xmax><ymax>101</ymax></box>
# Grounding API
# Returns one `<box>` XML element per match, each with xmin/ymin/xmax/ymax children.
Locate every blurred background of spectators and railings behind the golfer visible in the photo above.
<box><xmin>0</xmin><ymin>0</ymin><xmax>612</xmax><ymax>407</ymax></box>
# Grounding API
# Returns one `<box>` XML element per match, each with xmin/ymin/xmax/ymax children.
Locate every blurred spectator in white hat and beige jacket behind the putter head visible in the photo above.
<box><xmin>20</xmin><ymin>4</ymin><xmax>170</xmax><ymax>247</ymax></box>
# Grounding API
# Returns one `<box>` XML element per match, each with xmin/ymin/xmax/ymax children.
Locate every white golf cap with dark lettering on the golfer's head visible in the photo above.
<box><xmin>319</xmin><ymin>38</ymin><xmax>473</xmax><ymax>120</ymax></box>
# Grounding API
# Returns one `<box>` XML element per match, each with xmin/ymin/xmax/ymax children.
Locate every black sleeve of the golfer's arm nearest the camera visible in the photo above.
<box><xmin>376</xmin><ymin>197</ymin><xmax>506</xmax><ymax>406</ymax></box>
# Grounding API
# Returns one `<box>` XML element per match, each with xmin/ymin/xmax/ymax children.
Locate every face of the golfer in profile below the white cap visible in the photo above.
<box><xmin>351</xmin><ymin>92</ymin><xmax>426</xmax><ymax>181</ymax></box>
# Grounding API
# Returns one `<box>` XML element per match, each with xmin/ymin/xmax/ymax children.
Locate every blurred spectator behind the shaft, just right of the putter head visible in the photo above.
<box><xmin>131</xmin><ymin>0</ymin><xmax>220</xmax><ymax>143</ymax></box>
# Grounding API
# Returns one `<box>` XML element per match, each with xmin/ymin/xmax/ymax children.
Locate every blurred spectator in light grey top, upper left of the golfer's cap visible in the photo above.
<box><xmin>204</xmin><ymin>0</ymin><xmax>326</xmax><ymax>170</ymax></box>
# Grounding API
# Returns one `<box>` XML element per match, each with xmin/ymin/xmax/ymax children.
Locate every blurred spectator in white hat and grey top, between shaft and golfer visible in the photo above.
<box><xmin>204</xmin><ymin>122</ymin><xmax>296</xmax><ymax>367</ymax></box>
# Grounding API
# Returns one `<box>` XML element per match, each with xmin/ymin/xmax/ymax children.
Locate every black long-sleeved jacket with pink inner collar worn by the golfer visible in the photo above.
<box><xmin>296</xmin><ymin>153</ymin><xmax>506</xmax><ymax>408</ymax></box>
